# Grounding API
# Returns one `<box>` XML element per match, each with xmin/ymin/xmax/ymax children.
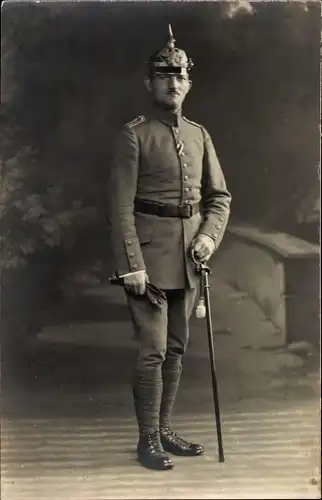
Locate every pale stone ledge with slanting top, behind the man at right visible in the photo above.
<box><xmin>213</xmin><ymin>221</ymin><xmax>320</xmax><ymax>345</ymax></box>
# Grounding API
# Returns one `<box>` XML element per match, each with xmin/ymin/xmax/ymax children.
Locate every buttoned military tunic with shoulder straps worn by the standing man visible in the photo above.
<box><xmin>109</xmin><ymin>108</ymin><xmax>231</xmax><ymax>290</ymax></box>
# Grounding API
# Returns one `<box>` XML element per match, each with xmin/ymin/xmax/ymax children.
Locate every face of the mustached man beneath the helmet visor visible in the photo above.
<box><xmin>147</xmin><ymin>74</ymin><xmax>191</xmax><ymax>111</ymax></box>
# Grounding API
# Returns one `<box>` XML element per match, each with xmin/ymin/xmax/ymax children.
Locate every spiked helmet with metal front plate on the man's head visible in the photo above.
<box><xmin>147</xmin><ymin>24</ymin><xmax>193</xmax><ymax>76</ymax></box>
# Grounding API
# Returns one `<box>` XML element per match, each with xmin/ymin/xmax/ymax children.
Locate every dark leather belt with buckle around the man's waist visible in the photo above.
<box><xmin>134</xmin><ymin>199</ymin><xmax>200</xmax><ymax>219</ymax></box>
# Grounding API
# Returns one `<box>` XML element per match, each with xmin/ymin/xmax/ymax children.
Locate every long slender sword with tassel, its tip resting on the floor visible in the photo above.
<box><xmin>192</xmin><ymin>251</ymin><xmax>225</xmax><ymax>462</ymax></box>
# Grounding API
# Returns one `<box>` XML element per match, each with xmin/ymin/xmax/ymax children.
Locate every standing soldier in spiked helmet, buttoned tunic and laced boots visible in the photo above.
<box><xmin>109</xmin><ymin>26</ymin><xmax>231</xmax><ymax>470</ymax></box>
